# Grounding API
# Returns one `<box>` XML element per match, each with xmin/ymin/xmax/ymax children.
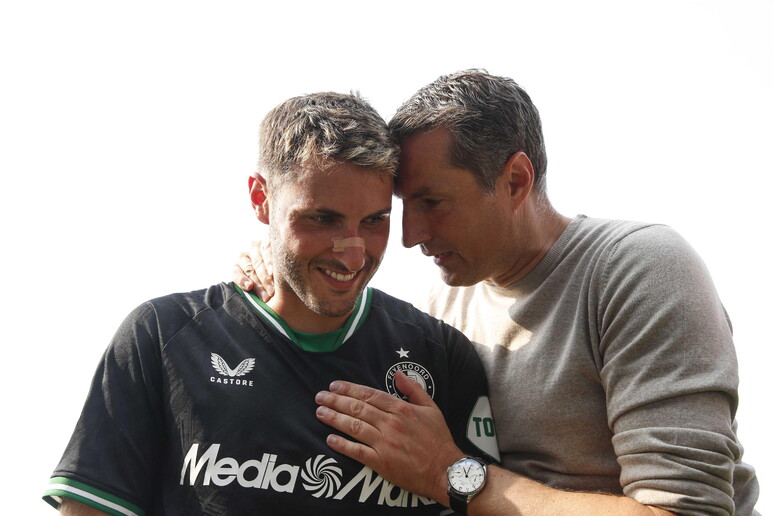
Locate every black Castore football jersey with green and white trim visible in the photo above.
<box><xmin>45</xmin><ymin>284</ymin><xmax>497</xmax><ymax>516</ymax></box>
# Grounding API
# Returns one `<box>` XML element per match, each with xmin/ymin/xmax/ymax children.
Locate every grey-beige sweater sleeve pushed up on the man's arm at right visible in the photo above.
<box><xmin>596</xmin><ymin>226</ymin><xmax>752</xmax><ymax>515</ymax></box>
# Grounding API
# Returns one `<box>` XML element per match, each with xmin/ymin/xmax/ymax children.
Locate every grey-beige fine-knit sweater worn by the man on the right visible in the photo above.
<box><xmin>423</xmin><ymin>216</ymin><xmax>758</xmax><ymax>515</ymax></box>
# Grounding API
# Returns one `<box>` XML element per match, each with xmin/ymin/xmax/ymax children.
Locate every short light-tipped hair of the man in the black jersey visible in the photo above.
<box><xmin>258</xmin><ymin>92</ymin><xmax>399</xmax><ymax>186</ymax></box>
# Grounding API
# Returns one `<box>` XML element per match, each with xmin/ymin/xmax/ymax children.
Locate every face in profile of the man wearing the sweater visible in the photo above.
<box><xmin>396</xmin><ymin>129</ymin><xmax>514</xmax><ymax>286</ymax></box>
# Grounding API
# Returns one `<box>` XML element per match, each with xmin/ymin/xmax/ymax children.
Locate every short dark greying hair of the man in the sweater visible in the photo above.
<box><xmin>389</xmin><ymin>69</ymin><xmax>547</xmax><ymax>195</ymax></box>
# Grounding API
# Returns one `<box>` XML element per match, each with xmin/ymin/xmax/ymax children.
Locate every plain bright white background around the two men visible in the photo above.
<box><xmin>0</xmin><ymin>0</ymin><xmax>774</xmax><ymax>514</ymax></box>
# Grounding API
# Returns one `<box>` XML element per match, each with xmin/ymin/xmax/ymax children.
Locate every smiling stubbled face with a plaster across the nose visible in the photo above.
<box><xmin>254</xmin><ymin>163</ymin><xmax>393</xmax><ymax>333</ymax></box>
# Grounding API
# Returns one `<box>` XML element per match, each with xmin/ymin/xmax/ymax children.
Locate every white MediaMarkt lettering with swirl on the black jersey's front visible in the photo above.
<box><xmin>180</xmin><ymin>443</ymin><xmax>435</xmax><ymax>507</ymax></box>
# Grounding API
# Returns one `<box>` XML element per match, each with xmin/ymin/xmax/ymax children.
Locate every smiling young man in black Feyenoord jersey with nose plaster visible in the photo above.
<box><xmin>44</xmin><ymin>93</ymin><xmax>498</xmax><ymax>515</ymax></box>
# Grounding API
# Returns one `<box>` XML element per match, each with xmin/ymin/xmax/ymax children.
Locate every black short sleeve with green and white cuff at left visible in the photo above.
<box><xmin>44</xmin><ymin>304</ymin><xmax>164</xmax><ymax>514</ymax></box>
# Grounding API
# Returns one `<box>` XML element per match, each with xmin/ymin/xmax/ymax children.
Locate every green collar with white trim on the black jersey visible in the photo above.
<box><xmin>234</xmin><ymin>285</ymin><xmax>373</xmax><ymax>352</ymax></box>
